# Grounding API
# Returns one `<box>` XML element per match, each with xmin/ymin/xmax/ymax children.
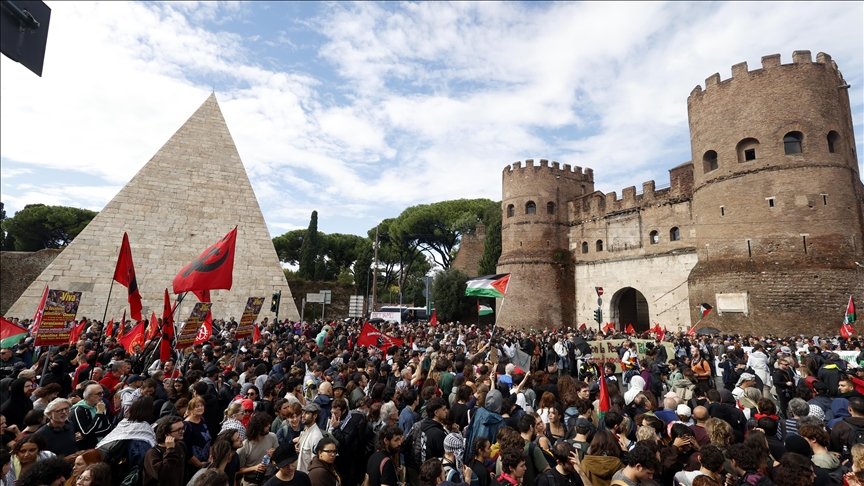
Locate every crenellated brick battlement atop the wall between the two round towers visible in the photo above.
<box><xmin>570</xmin><ymin>162</ymin><xmax>693</xmax><ymax>222</ymax></box>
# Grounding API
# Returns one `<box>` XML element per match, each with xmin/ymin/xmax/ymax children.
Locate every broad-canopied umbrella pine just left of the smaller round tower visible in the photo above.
<box><xmin>388</xmin><ymin>199</ymin><xmax>495</xmax><ymax>269</ymax></box>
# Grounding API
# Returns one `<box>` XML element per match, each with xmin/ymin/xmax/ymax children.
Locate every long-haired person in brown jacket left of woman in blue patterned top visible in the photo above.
<box><xmin>144</xmin><ymin>416</ymin><xmax>186</xmax><ymax>486</ymax></box>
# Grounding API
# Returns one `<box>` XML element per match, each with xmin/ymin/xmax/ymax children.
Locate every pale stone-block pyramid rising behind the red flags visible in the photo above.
<box><xmin>6</xmin><ymin>94</ymin><xmax>300</xmax><ymax>322</ymax></box>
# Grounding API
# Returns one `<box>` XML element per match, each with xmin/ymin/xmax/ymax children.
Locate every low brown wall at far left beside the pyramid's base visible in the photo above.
<box><xmin>0</xmin><ymin>248</ymin><xmax>61</xmax><ymax>319</ymax></box>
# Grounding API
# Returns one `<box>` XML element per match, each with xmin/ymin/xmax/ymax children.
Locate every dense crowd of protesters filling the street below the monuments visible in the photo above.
<box><xmin>0</xmin><ymin>312</ymin><xmax>864</xmax><ymax>486</ymax></box>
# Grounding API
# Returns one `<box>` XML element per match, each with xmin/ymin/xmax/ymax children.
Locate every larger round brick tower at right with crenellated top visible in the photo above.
<box><xmin>687</xmin><ymin>51</ymin><xmax>864</xmax><ymax>334</ymax></box>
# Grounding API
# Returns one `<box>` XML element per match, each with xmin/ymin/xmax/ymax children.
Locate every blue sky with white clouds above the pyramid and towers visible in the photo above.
<box><xmin>0</xmin><ymin>1</ymin><xmax>864</xmax><ymax>236</ymax></box>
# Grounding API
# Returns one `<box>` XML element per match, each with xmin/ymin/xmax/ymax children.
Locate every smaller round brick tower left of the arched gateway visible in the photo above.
<box><xmin>498</xmin><ymin>159</ymin><xmax>594</xmax><ymax>328</ymax></box>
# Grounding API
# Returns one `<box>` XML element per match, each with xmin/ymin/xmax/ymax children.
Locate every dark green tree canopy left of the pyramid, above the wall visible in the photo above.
<box><xmin>2</xmin><ymin>204</ymin><xmax>98</xmax><ymax>251</ymax></box>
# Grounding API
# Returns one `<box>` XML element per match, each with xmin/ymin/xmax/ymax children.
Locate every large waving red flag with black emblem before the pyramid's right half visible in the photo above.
<box><xmin>174</xmin><ymin>226</ymin><xmax>237</xmax><ymax>294</ymax></box>
